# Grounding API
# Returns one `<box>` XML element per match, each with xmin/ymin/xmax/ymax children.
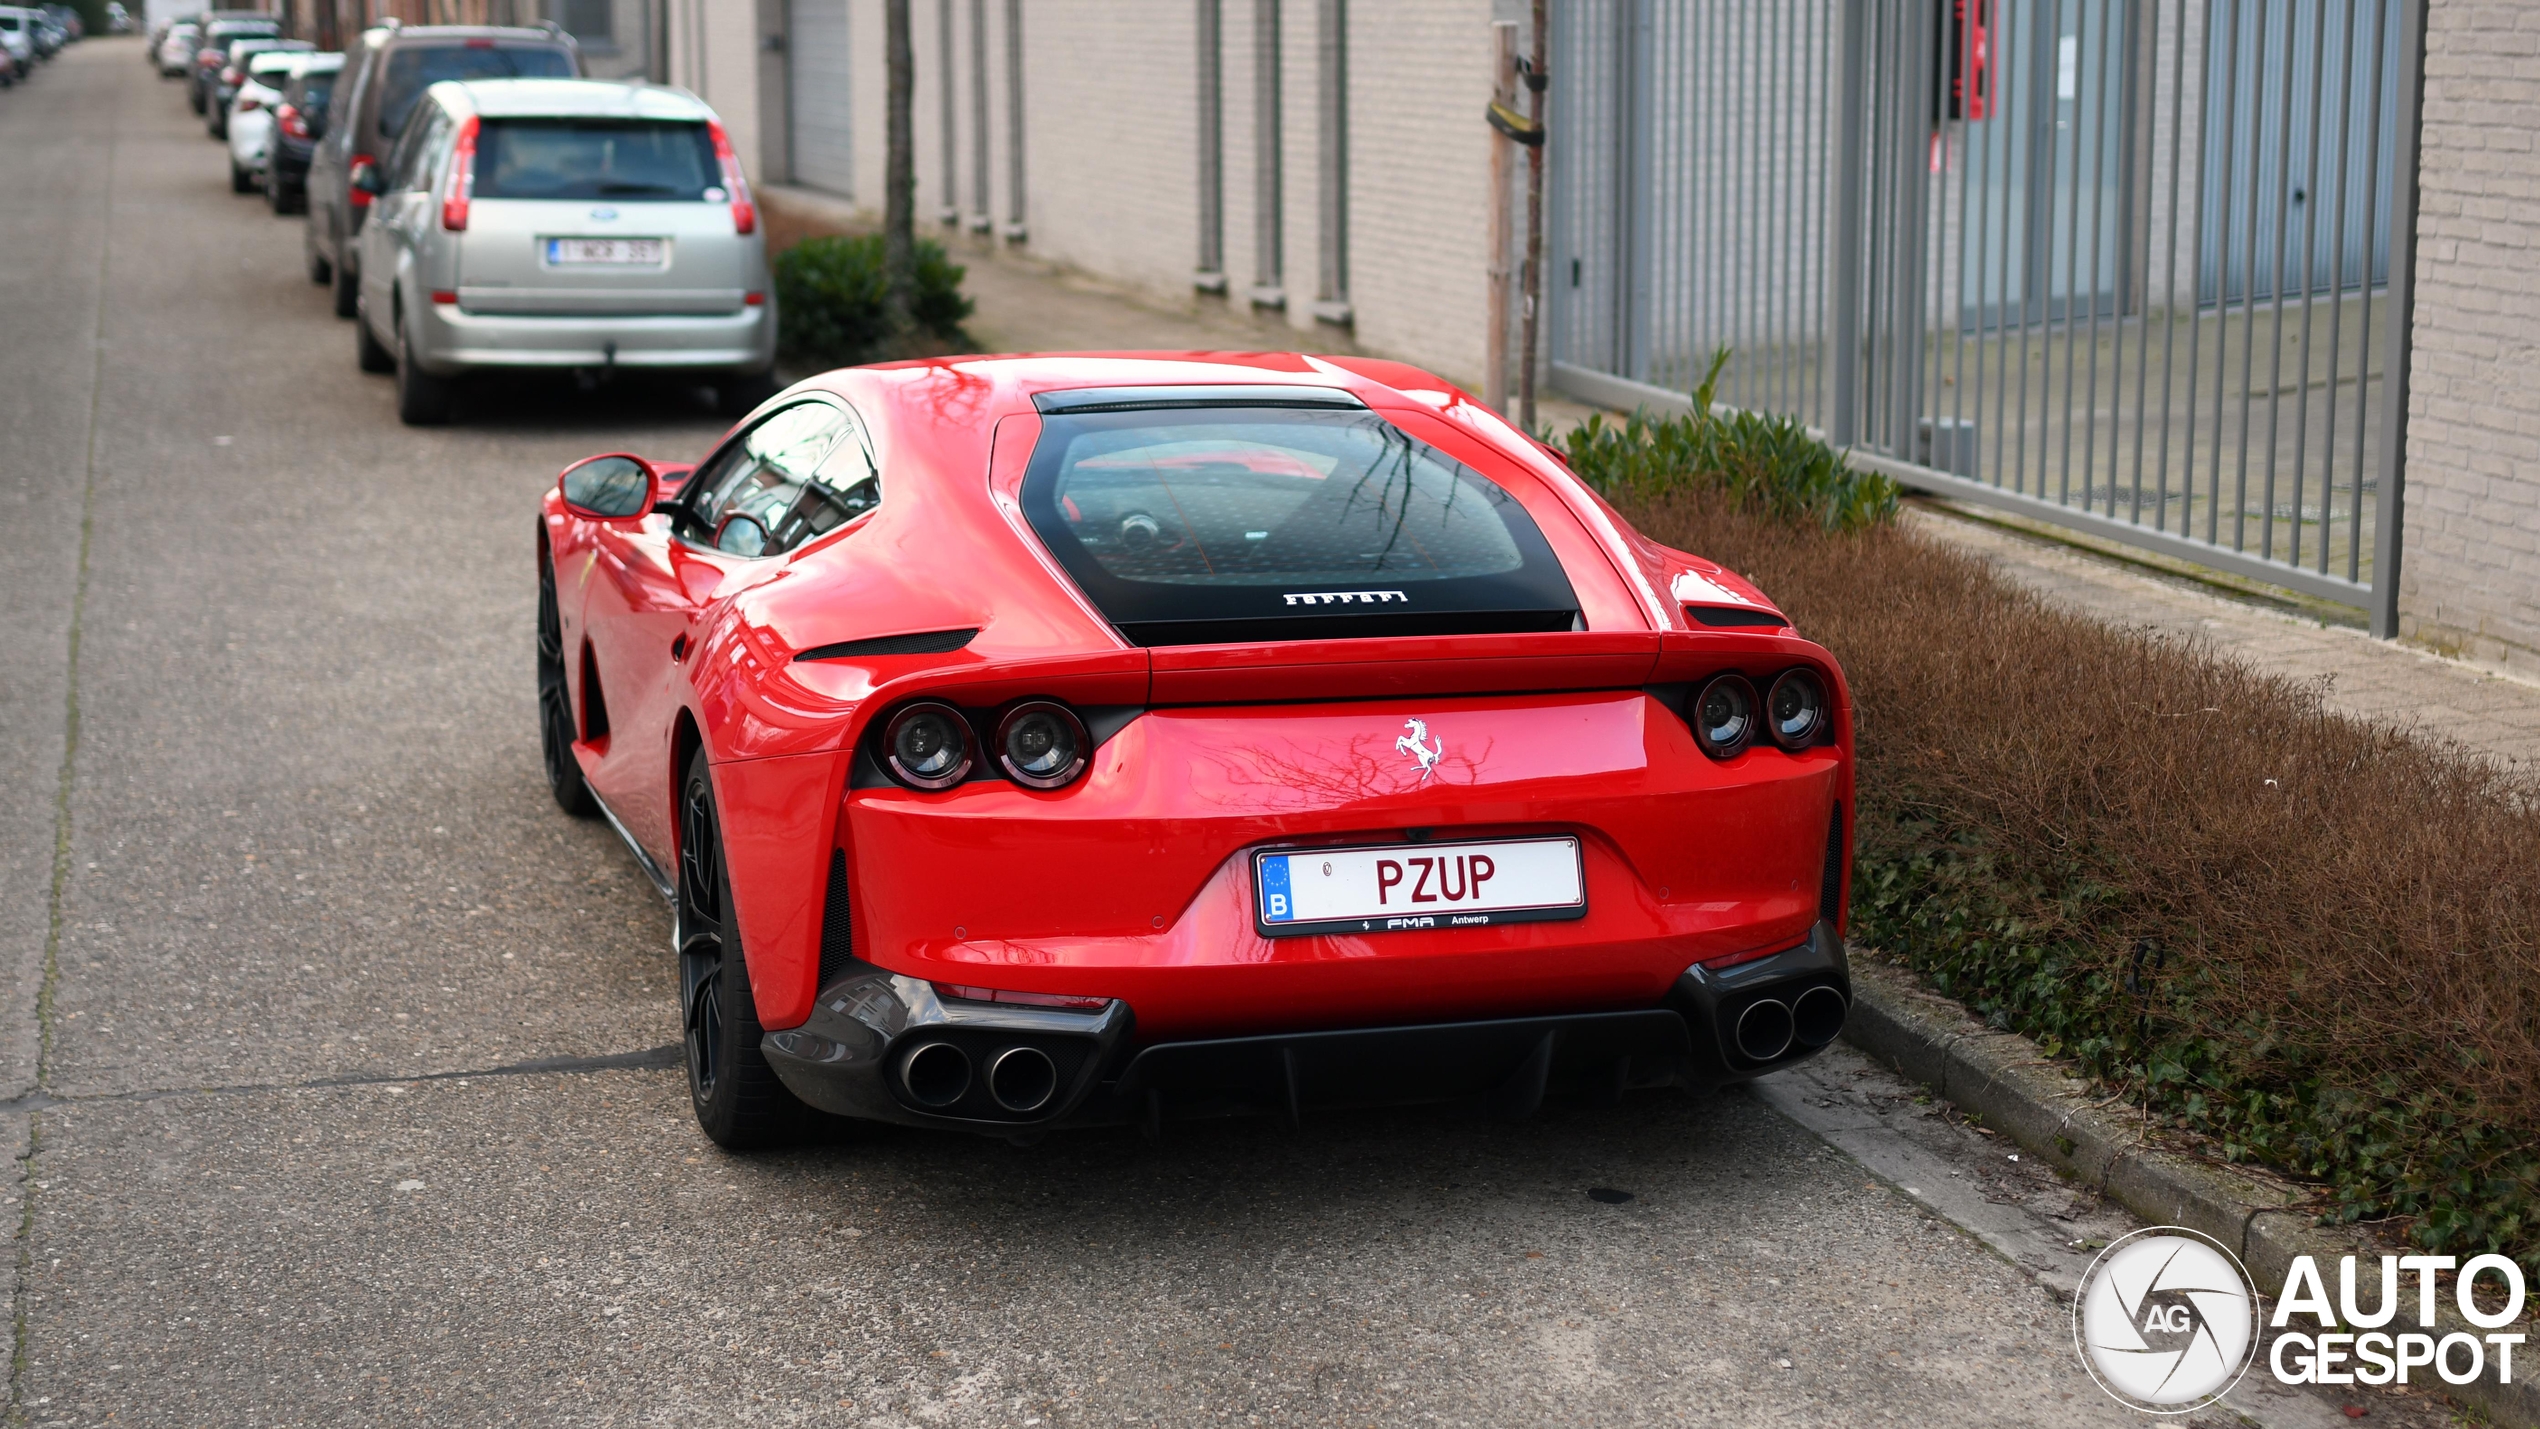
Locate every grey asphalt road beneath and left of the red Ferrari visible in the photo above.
<box><xmin>0</xmin><ymin>41</ymin><xmax>2225</xmax><ymax>1424</ymax></box>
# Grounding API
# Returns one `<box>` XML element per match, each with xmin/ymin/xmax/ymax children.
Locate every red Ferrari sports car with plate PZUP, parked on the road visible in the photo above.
<box><xmin>538</xmin><ymin>353</ymin><xmax>1852</xmax><ymax>1147</ymax></box>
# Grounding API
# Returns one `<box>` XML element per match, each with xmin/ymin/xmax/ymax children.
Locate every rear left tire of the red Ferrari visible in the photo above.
<box><xmin>678</xmin><ymin>749</ymin><xmax>810</xmax><ymax>1150</ymax></box>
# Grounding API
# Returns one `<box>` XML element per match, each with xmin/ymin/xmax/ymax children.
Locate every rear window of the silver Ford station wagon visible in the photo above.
<box><xmin>475</xmin><ymin>119</ymin><xmax>724</xmax><ymax>203</ymax></box>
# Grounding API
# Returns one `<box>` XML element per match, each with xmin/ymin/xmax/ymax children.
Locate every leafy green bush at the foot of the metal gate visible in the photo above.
<box><xmin>1534</xmin><ymin>348</ymin><xmax>1897</xmax><ymax>530</ymax></box>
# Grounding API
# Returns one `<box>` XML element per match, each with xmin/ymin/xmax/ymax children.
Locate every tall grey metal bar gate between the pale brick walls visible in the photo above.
<box><xmin>1547</xmin><ymin>0</ymin><xmax>2426</xmax><ymax>635</ymax></box>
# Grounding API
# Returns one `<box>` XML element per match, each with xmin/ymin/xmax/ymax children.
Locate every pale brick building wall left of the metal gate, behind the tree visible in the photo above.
<box><xmin>782</xmin><ymin>0</ymin><xmax>1509</xmax><ymax>386</ymax></box>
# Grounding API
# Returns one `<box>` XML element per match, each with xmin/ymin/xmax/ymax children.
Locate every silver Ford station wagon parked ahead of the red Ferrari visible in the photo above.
<box><xmin>351</xmin><ymin>79</ymin><xmax>777</xmax><ymax>424</ymax></box>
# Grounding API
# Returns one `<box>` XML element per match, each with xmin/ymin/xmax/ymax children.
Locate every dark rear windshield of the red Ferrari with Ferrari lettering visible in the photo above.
<box><xmin>1024</xmin><ymin>406</ymin><xmax>1577</xmax><ymax>645</ymax></box>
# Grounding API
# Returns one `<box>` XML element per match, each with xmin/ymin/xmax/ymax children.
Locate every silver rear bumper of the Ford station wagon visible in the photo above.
<box><xmin>414</xmin><ymin>302</ymin><xmax>777</xmax><ymax>376</ymax></box>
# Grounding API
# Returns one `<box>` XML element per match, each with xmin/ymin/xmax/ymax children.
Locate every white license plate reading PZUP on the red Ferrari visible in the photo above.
<box><xmin>1252</xmin><ymin>838</ymin><xmax>1588</xmax><ymax>937</ymax></box>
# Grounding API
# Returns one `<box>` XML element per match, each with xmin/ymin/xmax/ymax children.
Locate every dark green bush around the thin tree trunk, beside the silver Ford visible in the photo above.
<box><xmin>775</xmin><ymin>234</ymin><xmax>973</xmax><ymax>368</ymax></box>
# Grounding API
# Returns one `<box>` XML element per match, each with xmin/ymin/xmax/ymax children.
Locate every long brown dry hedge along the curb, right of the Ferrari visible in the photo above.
<box><xmin>1628</xmin><ymin>490</ymin><xmax>2540</xmax><ymax>1261</ymax></box>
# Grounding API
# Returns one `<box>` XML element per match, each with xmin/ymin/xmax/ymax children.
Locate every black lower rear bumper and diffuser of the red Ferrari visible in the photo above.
<box><xmin>762</xmin><ymin>924</ymin><xmax>1852</xmax><ymax>1137</ymax></box>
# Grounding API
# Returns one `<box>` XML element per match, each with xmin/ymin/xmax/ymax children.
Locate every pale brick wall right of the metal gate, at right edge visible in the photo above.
<box><xmin>2400</xmin><ymin>0</ymin><xmax>2540</xmax><ymax>675</ymax></box>
